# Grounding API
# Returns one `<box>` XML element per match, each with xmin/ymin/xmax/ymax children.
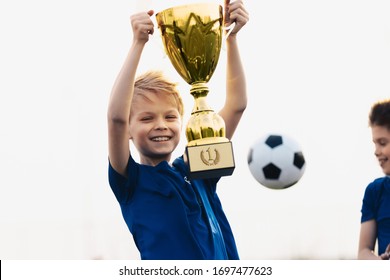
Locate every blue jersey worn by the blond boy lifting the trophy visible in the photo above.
<box><xmin>109</xmin><ymin>157</ymin><xmax>238</xmax><ymax>260</ymax></box>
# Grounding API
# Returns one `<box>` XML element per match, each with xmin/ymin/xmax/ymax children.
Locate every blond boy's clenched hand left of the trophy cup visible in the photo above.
<box><xmin>130</xmin><ymin>10</ymin><xmax>154</xmax><ymax>43</ymax></box>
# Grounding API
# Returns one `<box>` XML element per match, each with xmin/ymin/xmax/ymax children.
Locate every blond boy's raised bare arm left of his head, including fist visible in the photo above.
<box><xmin>107</xmin><ymin>11</ymin><xmax>154</xmax><ymax>176</ymax></box>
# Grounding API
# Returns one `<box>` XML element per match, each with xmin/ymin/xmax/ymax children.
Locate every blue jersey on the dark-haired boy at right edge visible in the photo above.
<box><xmin>361</xmin><ymin>177</ymin><xmax>390</xmax><ymax>255</ymax></box>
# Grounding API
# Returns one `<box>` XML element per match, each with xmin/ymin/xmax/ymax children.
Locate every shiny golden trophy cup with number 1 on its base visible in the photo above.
<box><xmin>156</xmin><ymin>3</ymin><xmax>235</xmax><ymax>179</ymax></box>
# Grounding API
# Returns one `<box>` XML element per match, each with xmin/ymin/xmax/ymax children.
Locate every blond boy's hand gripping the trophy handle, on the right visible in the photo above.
<box><xmin>224</xmin><ymin>0</ymin><xmax>249</xmax><ymax>36</ymax></box>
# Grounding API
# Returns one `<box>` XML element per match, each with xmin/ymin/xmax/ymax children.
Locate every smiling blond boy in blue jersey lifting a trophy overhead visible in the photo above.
<box><xmin>107</xmin><ymin>0</ymin><xmax>248</xmax><ymax>260</ymax></box>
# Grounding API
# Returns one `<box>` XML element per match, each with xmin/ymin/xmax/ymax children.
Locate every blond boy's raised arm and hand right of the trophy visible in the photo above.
<box><xmin>219</xmin><ymin>0</ymin><xmax>249</xmax><ymax>139</ymax></box>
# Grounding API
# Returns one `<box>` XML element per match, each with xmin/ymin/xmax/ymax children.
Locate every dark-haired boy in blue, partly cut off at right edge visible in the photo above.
<box><xmin>358</xmin><ymin>100</ymin><xmax>390</xmax><ymax>260</ymax></box>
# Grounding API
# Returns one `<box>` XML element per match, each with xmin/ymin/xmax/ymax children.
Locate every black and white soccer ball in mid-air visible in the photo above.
<box><xmin>248</xmin><ymin>134</ymin><xmax>306</xmax><ymax>189</ymax></box>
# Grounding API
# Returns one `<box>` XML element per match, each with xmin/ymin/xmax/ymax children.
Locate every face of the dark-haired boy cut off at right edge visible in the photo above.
<box><xmin>371</xmin><ymin>125</ymin><xmax>390</xmax><ymax>175</ymax></box>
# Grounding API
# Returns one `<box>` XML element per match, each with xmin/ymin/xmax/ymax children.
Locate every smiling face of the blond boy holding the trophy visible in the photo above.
<box><xmin>129</xmin><ymin>89</ymin><xmax>182</xmax><ymax>166</ymax></box>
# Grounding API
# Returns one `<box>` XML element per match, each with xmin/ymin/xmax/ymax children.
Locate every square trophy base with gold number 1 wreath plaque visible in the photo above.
<box><xmin>186</xmin><ymin>141</ymin><xmax>235</xmax><ymax>179</ymax></box>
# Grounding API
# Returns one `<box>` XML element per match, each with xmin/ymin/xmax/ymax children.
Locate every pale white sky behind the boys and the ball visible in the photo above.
<box><xmin>0</xmin><ymin>0</ymin><xmax>390</xmax><ymax>259</ymax></box>
